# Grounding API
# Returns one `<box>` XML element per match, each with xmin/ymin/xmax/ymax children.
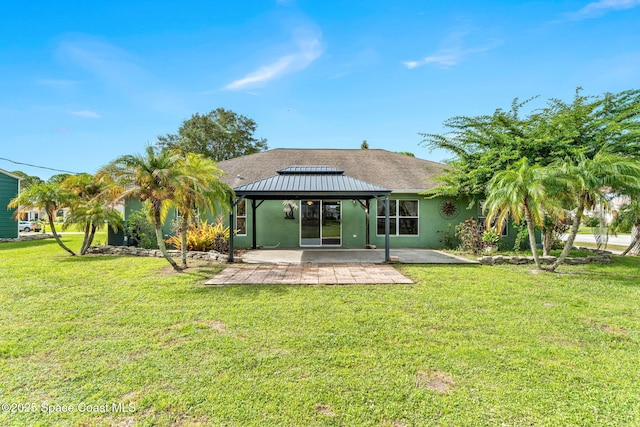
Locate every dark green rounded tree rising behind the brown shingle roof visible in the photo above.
<box><xmin>157</xmin><ymin>108</ymin><xmax>268</xmax><ymax>162</ymax></box>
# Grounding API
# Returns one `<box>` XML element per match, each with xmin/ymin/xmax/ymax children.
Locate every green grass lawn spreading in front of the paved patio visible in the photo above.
<box><xmin>0</xmin><ymin>235</ymin><xmax>640</xmax><ymax>427</ymax></box>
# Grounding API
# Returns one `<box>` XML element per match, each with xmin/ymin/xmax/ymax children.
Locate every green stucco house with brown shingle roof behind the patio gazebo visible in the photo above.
<box><xmin>112</xmin><ymin>148</ymin><xmax>515</xmax><ymax>252</ymax></box>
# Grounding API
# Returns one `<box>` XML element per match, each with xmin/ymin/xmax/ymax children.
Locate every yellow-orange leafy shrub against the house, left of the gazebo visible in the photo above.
<box><xmin>166</xmin><ymin>217</ymin><xmax>231</xmax><ymax>253</ymax></box>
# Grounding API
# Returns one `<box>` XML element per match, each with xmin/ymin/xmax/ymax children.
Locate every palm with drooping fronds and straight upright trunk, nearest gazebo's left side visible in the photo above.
<box><xmin>173</xmin><ymin>153</ymin><xmax>233</xmax><ymax>268</ymax></box>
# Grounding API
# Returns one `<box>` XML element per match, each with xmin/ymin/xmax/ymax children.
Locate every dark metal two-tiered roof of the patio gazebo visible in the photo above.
<box><xmin>233</xmin><ymin>166</ymin><xmax>391</xmax><ymax>199</ymax></box>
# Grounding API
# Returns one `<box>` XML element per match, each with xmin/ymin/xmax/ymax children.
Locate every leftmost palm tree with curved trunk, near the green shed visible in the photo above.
<box><xmin>9</xmin><ymin>183</ymin><xmax>75</xmax><ymax>256</ymax></box>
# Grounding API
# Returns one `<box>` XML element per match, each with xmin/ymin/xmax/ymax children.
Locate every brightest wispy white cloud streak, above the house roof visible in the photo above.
<box><xmin>223</xmin><ymin>27</ymin><xmax>323</xmax><ymax>90</ymax></box>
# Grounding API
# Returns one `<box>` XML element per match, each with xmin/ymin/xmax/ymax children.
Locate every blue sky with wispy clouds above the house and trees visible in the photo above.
<box><xmin>0</xmin><ymin>0</ymin><xmax>640</xmax><ymax>178</ymax></box>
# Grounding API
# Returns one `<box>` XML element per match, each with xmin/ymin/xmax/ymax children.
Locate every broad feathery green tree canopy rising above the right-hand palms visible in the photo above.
<box><xmin>422</xmin><ymin>88</ymin><xmax>640</xmax><ymax>200</ymax></box>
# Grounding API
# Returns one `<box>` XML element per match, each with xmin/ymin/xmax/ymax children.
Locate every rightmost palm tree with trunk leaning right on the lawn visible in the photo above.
<box><xmin>549</xmin><ymin>152</ymin><xmax>640</xmax><ymax>271</ymax></box>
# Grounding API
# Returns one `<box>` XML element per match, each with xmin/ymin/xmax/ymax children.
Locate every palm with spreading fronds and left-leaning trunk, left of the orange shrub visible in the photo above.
<box><xmin>97</xmin><ymin>146</ymin><xmax>186</xmax><ymax>271</ymax></box>
